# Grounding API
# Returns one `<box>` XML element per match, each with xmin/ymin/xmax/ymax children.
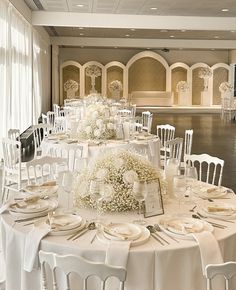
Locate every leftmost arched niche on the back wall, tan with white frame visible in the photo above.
<box><xmin>60</xmin><ymin>60</ymin><xmax>81</xmax><ymax>105</ymax></box>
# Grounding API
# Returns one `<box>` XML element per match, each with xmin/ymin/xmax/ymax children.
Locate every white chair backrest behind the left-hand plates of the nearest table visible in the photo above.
<box><xmin>26</xmin><ymin>156</ymin><xmax>68</xmax><ymax>184</ymax></box>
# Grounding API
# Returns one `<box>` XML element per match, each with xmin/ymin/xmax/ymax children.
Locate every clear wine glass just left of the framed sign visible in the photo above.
<box><xmin>133</xmin><ymin>181</ymin><xmax>147</xmax><ymax>225</ymax></box>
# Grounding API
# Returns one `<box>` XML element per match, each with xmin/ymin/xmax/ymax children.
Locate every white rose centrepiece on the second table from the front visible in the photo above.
<box><xmin>78</xmin><ymin>103</ymin><xmax>116</xmax><ymax>140</ymax></box>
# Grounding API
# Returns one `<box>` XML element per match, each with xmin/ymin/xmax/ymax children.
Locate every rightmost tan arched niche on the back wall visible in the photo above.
<box><xmin>212</xmin><ymin>63</ymin><xmax>230</xmax><ymax>105</ymax></box>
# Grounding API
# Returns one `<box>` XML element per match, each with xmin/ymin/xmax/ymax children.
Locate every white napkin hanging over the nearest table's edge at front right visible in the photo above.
<box><xmin>192</xmin><ymin>231</ymin><xmax>223</xmax><ymax>276</ymax></box>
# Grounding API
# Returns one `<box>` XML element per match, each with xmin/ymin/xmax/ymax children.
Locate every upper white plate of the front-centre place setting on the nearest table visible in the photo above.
<box><xmin>101</xmin><ymin>223</ymin><xmax>142</xmax><ymax>241</ymax></box>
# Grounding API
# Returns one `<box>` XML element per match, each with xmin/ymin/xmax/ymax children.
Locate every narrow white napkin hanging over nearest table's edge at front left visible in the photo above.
<box><xmin>23</xmin><ymin>223</ymin><xmax>51</xmax><ymax>272</ymax></box>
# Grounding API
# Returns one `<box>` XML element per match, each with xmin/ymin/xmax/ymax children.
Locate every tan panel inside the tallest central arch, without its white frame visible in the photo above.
<box><xmin>128</xmin><ymin>57</ymin><xmax>166</xmax><ymax>93</ymax></box>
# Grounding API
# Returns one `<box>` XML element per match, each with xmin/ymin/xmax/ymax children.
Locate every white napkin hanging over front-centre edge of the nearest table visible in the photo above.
<box><xmin>105</xmin><ymin>241</ymin><xmax>131</xmax><ymax>268</ymax></box>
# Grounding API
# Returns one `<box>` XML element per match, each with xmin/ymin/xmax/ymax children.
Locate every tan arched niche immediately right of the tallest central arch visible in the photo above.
<box><xmin>170</xmin><ymin>63</ymin><xmax>191</xmax><ymax>105</ymax></box>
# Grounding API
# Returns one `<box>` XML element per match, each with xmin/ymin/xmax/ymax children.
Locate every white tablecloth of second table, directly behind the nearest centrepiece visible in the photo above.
<box><xmin>41</xmin><ymin>137</ymin><xmax>160</xmax><ymax>167</ymax></box>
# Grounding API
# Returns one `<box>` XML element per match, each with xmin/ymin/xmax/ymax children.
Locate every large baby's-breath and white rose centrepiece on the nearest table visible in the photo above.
<box><xmin>75</xmin><ymin>149</ymin><xmax>165</xmax><ymax>212</ymax></box>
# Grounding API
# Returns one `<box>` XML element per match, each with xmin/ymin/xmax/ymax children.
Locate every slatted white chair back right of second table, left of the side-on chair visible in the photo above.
<box><xmin>165</xmin><ymin>138</ymin><xmax>183</xmax><ymax>164</ymax></box>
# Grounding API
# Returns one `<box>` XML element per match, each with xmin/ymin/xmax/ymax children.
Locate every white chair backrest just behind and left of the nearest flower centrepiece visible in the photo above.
<box><xmin>49</xmin><ymin>144</ymin><xmax>87</xmax><ymax>171</ymax></box>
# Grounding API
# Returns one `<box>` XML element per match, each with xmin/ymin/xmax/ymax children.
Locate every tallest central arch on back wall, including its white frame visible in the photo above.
<box><xmin>126</xmin><ymin>51</ymin><xmax>169</xmax><ymax>93</ymax></box>
